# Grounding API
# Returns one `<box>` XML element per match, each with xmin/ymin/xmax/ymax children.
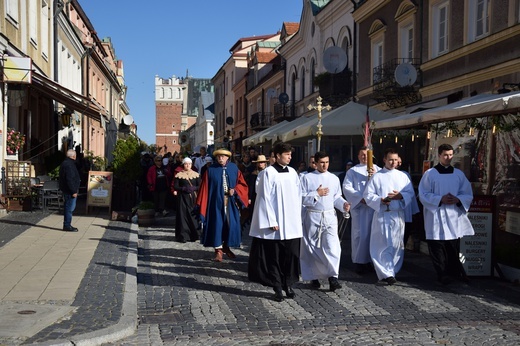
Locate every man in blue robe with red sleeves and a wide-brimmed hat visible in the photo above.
<box><xmin>196</xmin><ymin>149</ymin><xmax>248</xmax><ymax>262</ymax></box>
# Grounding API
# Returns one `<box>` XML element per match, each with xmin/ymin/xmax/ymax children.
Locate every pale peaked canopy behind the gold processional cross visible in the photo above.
<box><xmin>281</xmin><ymin>101</ymin><xmax>396</xmax><ymax>141</ymax></box>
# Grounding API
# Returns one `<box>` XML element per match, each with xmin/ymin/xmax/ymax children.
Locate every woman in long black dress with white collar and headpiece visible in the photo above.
<box><xmin>172</xmin><ymin>157</ymin><xmax>200</xmax><ymax>243</ymax></box>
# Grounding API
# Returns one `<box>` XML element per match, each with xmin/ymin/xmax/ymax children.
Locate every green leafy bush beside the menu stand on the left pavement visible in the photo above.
<box><xmin>112</xmin><ymin>136</ymin><xmax>141</xmax><ymax>182</ymax></box>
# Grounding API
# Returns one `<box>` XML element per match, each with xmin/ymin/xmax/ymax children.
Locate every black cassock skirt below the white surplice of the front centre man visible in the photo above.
<box><xmin>248</xmin><ymin>238</ymin><xmax>300</xmax><ymax>288</ymax></box>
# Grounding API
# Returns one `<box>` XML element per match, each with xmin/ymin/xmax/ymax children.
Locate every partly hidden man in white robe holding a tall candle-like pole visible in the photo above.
<box><xmin>342</xmin><ymin>147</ymin><xmax>380</xmax><ymax>274</ymax></box>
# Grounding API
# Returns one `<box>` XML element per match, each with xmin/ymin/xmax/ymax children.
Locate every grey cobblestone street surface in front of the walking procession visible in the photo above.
<box><xmin>117</xmin><ymin>220</ymin><xmax>520</xmax><ymax>346</ymax></box>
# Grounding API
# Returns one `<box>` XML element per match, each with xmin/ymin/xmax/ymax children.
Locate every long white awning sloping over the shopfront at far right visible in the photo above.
<box><xmin>376</xmin><ymin>92</ymin><xmax>520</xmax><ymax>130</ymax></box>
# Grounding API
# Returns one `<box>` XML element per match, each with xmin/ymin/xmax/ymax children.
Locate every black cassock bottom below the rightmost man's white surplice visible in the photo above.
<box><xmin>427</xmin><ymin>238</ymin><xmax>466</xmax><ymax>280</ymax></box>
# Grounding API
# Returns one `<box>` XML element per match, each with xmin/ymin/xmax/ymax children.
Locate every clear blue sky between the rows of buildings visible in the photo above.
<box><xmin>79</xmin><ymin>0</ymin><xmax>303</xmax><ymax>144</ymax></box>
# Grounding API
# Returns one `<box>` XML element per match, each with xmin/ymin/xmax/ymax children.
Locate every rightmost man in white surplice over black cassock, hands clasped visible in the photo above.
<box><xmin>419</xmin><ymin>144</ymin><xmax>475</xmax><ymax>284</ymax></box>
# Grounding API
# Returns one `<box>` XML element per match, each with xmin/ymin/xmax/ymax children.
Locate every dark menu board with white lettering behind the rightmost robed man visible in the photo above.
<box><xmin>460</xmin><ymin>196</ymin><xmax>493</xmax><ymax>276</ymax></box>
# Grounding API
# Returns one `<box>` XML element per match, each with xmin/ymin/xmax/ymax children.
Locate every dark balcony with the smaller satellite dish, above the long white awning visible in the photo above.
<box><xmin>372</xmin><ymin>58</ymin><xmax>421</xmax><ymax>109</ymax></box>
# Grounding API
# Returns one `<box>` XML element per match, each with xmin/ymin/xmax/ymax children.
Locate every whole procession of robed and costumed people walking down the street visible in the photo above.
<box><xmin>136</xmin><ymin>142</ymin><xmax>474</xmax><ymax>302</ymax></box>
